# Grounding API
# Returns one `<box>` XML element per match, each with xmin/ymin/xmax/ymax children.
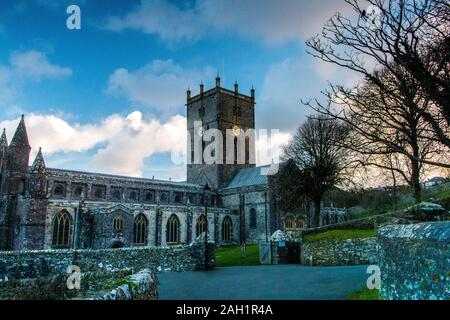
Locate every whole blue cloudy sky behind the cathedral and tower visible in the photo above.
<box><xmin>0</xmin><ymin>0</ymin><xmax>358</xmax><ymax>180</ymax></box>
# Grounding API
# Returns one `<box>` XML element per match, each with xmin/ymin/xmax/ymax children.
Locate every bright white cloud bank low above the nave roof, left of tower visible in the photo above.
<box><xmin>0</xmin><ymin>111</ymin><xmax>186</xmax><ymax>176</ymax></box>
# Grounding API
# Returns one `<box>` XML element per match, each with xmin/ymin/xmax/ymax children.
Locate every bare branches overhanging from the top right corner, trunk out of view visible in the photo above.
<box><xmin>306</xmin><ymin>0</ymin><xmax>450</xmax><ymax>150</ymax></box>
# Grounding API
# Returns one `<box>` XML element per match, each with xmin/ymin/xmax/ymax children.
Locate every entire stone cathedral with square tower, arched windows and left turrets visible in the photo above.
<box><xmin>0</xmin><ymin>77</ymin><xmax>342</xmax><ymax>250</ymax></box>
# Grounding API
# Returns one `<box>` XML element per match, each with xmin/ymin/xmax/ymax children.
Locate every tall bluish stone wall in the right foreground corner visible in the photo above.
<box><xmin>378</xmin><ymin>222</ymin><xmax>450</xmax><ymax>300</ymax></box>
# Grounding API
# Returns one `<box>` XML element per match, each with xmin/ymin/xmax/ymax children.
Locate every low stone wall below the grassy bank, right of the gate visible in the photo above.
<box><xmin>300</xmin><ymin>238</ymin><xmax>377</xmax><ymax>266</ymax></box>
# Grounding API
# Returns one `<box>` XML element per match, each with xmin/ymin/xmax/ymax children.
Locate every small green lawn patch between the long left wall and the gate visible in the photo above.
<box><xmin>216</xmin><ymin>244</ymin><xmax>260</xmax><ymax>267</ymax></box>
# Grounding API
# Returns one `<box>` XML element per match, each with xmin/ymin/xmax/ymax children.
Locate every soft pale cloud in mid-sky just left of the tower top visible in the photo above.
<box><xmin>106</xmin><ymin>60</ymin><xmax>215</xmax><ymax>111</ymax></box>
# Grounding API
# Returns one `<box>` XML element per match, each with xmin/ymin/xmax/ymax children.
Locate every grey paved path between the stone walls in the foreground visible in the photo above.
<box><xmin>158</xmin><ymin>265</ymin><xmax>369</xmax><ymax>300</ymax></box>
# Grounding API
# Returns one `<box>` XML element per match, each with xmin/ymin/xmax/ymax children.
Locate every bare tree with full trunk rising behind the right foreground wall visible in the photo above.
<box><xmin>306</xmin><ymin>65</ymin><xmax>449</xmax><ymax>202</ymax></box>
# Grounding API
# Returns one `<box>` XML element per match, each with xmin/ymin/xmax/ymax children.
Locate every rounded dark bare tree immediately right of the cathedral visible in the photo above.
<box><xmin>284</xmin><ymin>115</ymin><xmax>350</xmax><ymax>226</ymax></box>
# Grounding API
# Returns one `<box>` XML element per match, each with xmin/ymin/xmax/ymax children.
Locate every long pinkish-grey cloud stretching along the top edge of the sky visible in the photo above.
<box><xmin>106</xmin><ymin>0</ymin><xmax>350</xmax><ymax>44</ymax></box>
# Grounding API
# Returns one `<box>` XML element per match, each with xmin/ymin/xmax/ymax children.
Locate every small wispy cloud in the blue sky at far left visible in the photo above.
<box><xmin>10</xmin><ymin>50</ymin><xmax>72</xmax><ymax>81</ymax></box>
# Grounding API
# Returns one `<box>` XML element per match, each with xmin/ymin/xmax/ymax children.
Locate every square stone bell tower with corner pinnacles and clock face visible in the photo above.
<box><xmin>186</xmin><ymin>76</ymin><xmax>255</xmax><ymax>189</ymax></box>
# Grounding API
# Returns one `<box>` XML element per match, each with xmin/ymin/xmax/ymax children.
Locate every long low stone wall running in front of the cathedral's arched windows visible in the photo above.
<box><xmin>0</xmin><ymin>243</ymin><xmax>214</xmax><ymax>280</ymax></box>
